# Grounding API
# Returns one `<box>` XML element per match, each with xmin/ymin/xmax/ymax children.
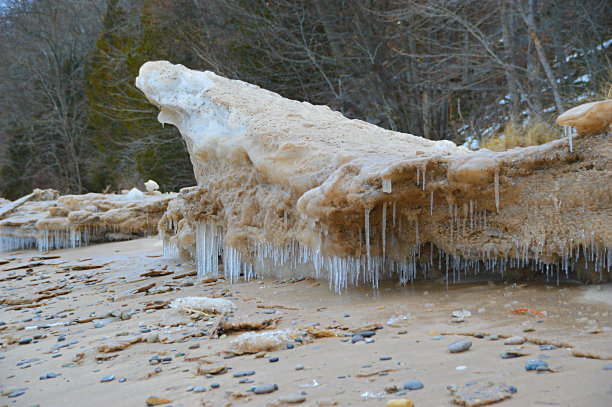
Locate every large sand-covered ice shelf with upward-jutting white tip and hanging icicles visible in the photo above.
<box><xmin>136</xmin><ymin>61</ymin><xmax>612</xmax><ymax>291</ymax></box>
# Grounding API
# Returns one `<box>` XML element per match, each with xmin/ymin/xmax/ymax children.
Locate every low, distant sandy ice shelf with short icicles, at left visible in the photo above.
<box><xmin>0</xmin><ymin>189</ymin><xmax>177</xmax><ymax>252</ymax></box>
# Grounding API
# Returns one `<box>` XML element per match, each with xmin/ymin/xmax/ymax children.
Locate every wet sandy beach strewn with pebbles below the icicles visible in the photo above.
<box><xmin>0</xmin><ymin>239</ymin><xmax>612</xmax><ymax>407</ymax></box>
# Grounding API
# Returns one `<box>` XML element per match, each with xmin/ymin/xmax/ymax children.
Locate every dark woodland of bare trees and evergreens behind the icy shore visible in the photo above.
<box><xmin>0</xmin><ymin>0</ymin><xmax>612</xmax><ymax>198</ymax></box>
